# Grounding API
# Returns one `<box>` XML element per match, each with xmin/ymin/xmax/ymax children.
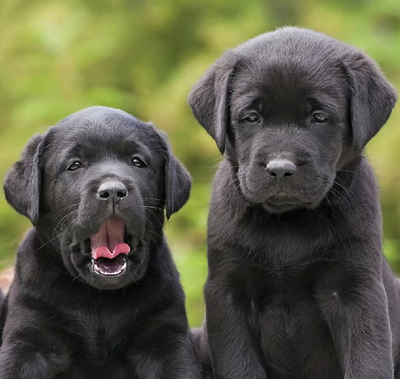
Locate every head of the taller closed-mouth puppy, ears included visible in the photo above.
<box><xmin>189</xmin><ymin>28</ymin><xmax>396</xmax><ymax>213</ymax></box>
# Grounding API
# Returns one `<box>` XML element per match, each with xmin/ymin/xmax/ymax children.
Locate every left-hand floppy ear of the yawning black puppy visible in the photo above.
<box><xmin>4</xmin><ymin>135</ymin><xmax>44</xmax><ymax>225</ymax></box>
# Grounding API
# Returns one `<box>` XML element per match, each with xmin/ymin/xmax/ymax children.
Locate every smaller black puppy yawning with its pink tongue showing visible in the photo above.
<box><xmin>0</xmin><ymin>107</ymin><xmax>200</xmax><ymax>379</ymax></box>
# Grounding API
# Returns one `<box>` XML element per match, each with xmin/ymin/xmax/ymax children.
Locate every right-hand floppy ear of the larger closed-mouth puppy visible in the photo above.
<box><xmin>346</xmin><ymin>52</ymin><xmax>397</xmax><ymax>151</ymax></box>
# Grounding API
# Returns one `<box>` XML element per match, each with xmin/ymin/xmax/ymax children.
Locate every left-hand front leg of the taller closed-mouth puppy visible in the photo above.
<box><xmin>205</xmin><ymin>281</ymin><xmax>267</xmax><ymax>379</ymax></box>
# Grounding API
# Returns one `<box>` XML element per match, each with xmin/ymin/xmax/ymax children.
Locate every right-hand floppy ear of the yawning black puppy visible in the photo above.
<box><xmin>159</xmin><ymin>132</ymin><xmax>192</xmax><ymax>219</ymax></box>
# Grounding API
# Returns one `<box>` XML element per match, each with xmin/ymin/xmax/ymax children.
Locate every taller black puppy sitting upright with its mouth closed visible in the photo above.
<box><xmin>189</xmin><ymin>28</ymin><xmax>400</xmax><ymax>379</ymax></box>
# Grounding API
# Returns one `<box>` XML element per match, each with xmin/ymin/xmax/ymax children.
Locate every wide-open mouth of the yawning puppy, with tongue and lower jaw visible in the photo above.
<box><xmin>90</xmin><ymin>217</ymin><xmax>131</xmax><ymax>276</ymax></box>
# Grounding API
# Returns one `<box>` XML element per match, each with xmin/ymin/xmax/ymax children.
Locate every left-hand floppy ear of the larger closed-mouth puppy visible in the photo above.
<box><xmin>188</xmin><ymin>54</ymin><xmax>237</xmax><ymax>154</ymax></box>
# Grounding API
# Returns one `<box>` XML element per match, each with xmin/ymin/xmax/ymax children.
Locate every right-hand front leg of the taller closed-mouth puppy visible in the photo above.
<box><xmin>317</xmin><ymin>272</ymin><xmax>394</xmax><ymax>379</ymax></box>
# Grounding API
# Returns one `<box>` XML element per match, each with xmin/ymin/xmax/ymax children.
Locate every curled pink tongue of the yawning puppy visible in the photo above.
<box><xmin>90</xmin><ymin>217</ymin><xmax>131</xmax><ymax>259</ymax></box>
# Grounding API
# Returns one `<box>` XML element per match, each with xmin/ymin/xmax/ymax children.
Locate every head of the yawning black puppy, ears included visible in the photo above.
<box><xmin>4</xmin><ymin>107</ymin><xmax>191</xmax><ymax>289</ymax></box>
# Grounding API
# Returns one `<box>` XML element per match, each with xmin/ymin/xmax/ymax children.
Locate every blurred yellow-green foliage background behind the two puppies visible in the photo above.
<box><xmin>0</xmin><ymin>0</ymin><xmax>400</xmax><ymax>326</ymax></box>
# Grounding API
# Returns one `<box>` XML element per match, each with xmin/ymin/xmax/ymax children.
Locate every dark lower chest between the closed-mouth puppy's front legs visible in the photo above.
<box><xmin>253</xmin><ymin>296</ymin><xmax>341</xmax><ymax>379</ymax></box>
